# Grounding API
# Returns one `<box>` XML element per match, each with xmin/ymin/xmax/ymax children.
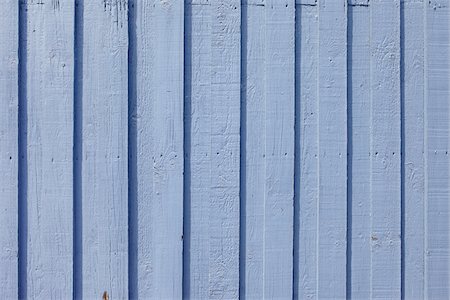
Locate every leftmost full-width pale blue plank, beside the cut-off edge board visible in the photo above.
<box><xmin>26</xmin><ymin>1</ymin><xmax>74</xmax><ymax>299</ymax></box>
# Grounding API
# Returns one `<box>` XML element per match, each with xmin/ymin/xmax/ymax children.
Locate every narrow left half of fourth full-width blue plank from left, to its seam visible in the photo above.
<box><xmin>183</xmin><ymin>1</ymin><xmax>213</xmax><ymax>299</ymax></box>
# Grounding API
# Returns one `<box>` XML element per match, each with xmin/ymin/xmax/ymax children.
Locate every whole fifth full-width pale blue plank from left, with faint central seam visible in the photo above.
<box><xmin>243</xmin><ymin>1</ymin><xmax>295</xmax><ymax>299</ymax></box>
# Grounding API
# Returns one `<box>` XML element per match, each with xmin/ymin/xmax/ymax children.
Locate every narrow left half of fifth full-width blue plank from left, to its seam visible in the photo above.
<box><xmin>241</xmin><ymin>0</ymin><xmax>266</xmax><ymax>299</ymax></box>
